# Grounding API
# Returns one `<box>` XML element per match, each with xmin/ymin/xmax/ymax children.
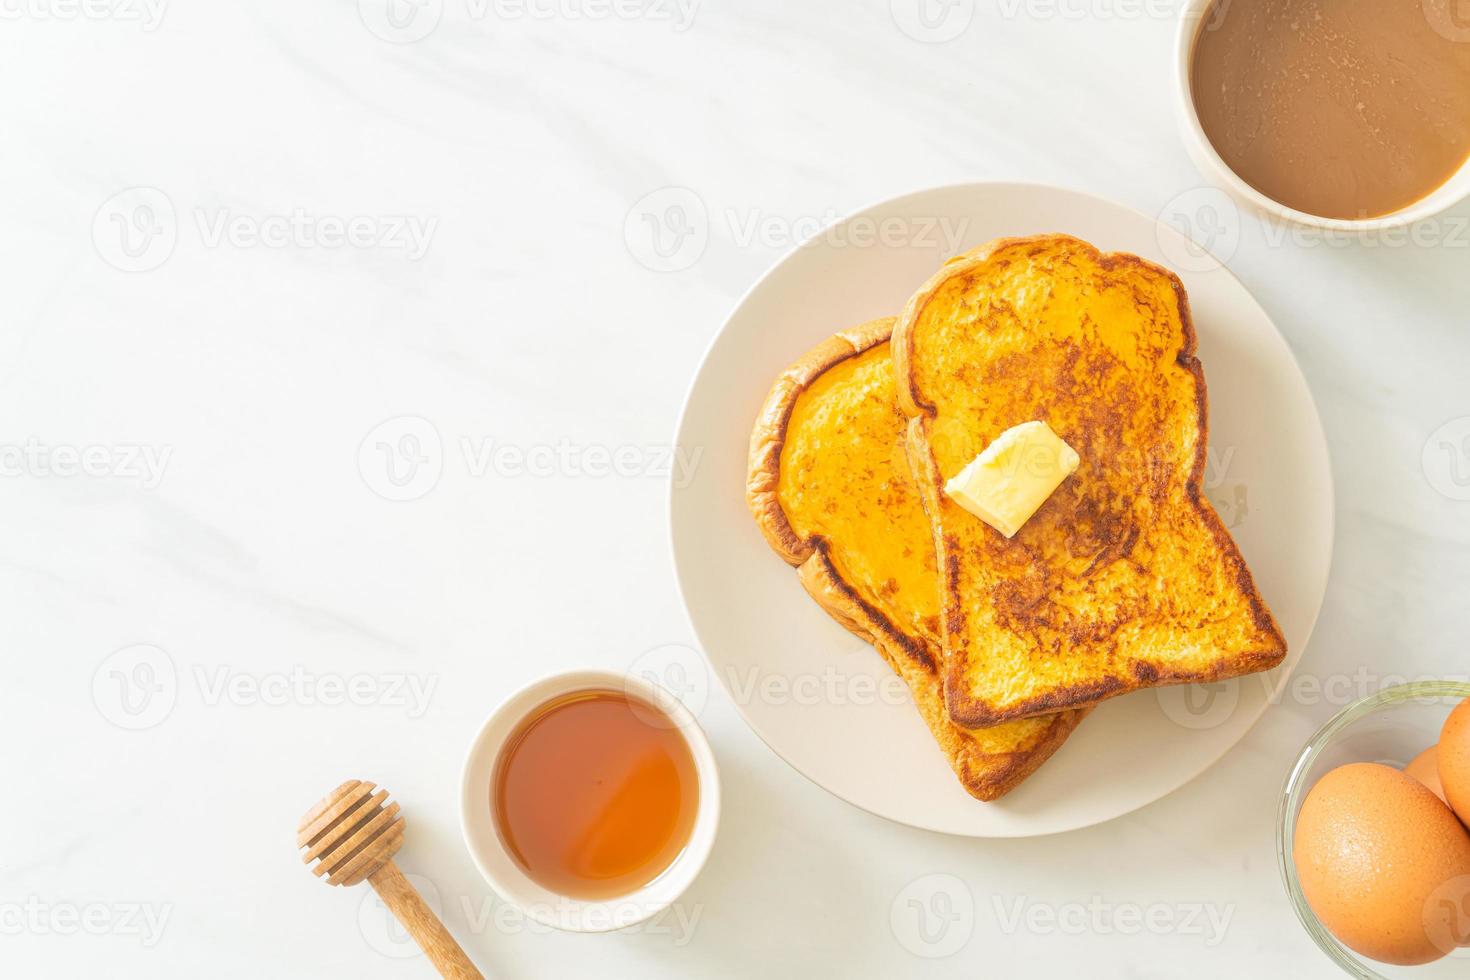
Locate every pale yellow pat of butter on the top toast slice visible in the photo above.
<box><xmin>944</xmin><ymin>422</ymin><xmax>1082</xmax><ymax>538</ymax></box>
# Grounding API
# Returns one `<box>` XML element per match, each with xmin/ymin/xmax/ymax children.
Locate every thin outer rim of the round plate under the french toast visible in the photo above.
<box><xmin>664</xmin><ymin>181</ymin><xmax>1338</xmax><ymax>840</ymax></box>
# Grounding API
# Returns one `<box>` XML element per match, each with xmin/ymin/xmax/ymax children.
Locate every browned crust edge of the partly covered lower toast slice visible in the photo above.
<box><xmin>745</xmin><ymin>317</ymin><xmax>1086</xmax><ymax>801</ymax></box>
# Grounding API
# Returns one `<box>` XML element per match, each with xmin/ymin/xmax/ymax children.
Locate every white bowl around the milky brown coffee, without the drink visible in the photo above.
<box><xmin>1175</xmin><ymin>0</ymin><xmax>1470</xmax><ymax>234</ymax></box>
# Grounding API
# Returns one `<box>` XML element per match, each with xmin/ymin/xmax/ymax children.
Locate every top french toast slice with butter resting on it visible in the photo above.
<box><xmin>892</xmin><ymin>235</ymin><xmax>1286</xmax><ymax>729</ymax></box>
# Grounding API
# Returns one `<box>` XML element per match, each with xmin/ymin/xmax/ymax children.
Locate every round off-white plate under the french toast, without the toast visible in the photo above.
<box><xmin>670</xmin><ymin>184</ymin><xmax>1333</xmax><ymax>837</ymax></box>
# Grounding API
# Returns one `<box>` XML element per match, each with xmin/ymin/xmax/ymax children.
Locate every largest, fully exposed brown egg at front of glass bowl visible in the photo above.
<box><xmin>1294</xmin><ymin>763</ymin><xmax>1470</xmax><ymax>967</ymax></box>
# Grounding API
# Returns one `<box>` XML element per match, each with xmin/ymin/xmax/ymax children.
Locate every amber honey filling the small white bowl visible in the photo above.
<box><xmin>490</xmin><ymin>691</ymin><xmax>700</xmax><ymax>901</ymax></box>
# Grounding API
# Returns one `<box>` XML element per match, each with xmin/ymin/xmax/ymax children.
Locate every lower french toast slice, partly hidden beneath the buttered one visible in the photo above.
<box><xmin>747</xmin><ymin>317</ymin><xmax>1085</xmax><ymax>801</ymax></box>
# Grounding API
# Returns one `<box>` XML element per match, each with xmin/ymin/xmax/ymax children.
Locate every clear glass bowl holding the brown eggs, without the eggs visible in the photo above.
<box><xmin>1276</xmin><ymin>680</ymin><xmax>1470</xmax><ymax>980</ymax></box>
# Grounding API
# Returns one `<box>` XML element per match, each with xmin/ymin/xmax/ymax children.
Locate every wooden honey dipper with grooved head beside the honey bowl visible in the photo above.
<box><xmin>295</xmin><ymin>779</ymin><xmax>485</xmax><ymax>980</ymax></box>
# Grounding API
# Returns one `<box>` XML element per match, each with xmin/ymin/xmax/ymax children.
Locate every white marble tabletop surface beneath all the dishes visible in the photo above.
<box><xmin>0</xmin><ymin>0</ymin><xmax>1470</xmax><ymax>979</ymax></box>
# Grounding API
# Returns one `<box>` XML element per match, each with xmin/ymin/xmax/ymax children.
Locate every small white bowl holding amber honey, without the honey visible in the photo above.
<box><xmin>460</xmin><ymin>670</ymin><xmax>720</xmax><ymax>933</ymax></box>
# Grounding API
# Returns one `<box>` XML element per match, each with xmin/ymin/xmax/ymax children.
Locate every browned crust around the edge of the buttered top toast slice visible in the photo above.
<box><xmin>892</xmin><ymin>235</ymin><xmax>1286</xmax><ymax>729</ymax></box>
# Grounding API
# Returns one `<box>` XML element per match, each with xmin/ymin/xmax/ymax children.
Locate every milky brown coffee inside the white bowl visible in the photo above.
<box><xmin>1191</xmin><ymin>0</ymin><xmax>1470</xmax><ymax>219</ymax></box>
